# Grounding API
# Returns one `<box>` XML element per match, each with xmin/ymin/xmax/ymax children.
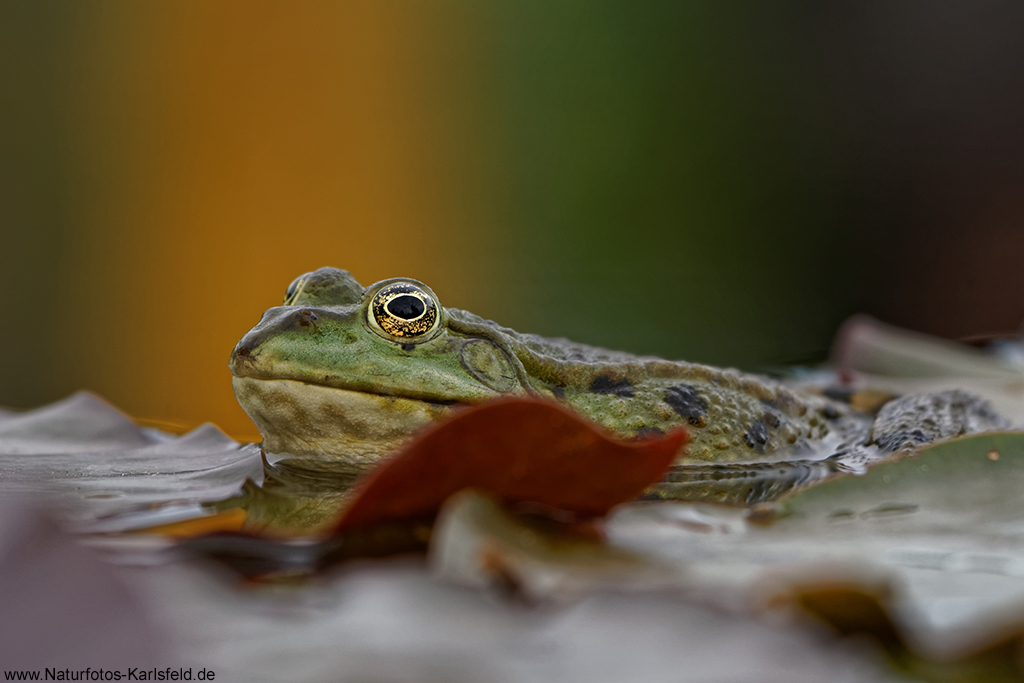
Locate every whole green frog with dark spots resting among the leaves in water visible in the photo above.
<box><xmin>228</xmin><ymin>267</ymin><xmax>1008</xmax><ymax>502</ymax></box>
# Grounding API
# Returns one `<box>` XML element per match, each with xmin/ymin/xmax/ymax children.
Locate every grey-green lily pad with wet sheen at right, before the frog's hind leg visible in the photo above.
<box><xmin>609</xmin><ymin>432</ymin><xmax>1024</xmax><ymax>652</ymax></box>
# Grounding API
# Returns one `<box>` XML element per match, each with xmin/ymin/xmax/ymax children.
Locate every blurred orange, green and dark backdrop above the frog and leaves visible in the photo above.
<box><xmin>0</xmin><ymin>0</ymin><xmax>1024</xmax><ymax>437</ymax></box>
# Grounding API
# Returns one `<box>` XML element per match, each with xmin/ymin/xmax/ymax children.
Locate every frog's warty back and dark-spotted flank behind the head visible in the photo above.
<box><xmin>451</xmin><ymin>310</ymin><xmax>867</xmax><ymax>462</ymax></box>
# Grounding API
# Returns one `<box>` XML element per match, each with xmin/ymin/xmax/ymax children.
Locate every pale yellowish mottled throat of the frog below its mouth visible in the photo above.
<box><xmin>231</xmin><ymin>377</ymin><xmax>452</xmax><ymax>468</ymax></box>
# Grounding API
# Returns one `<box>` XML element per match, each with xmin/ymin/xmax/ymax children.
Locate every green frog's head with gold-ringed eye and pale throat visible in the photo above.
<box><xmin>229</xmin><ymin>268</ymin><xmax>526</xmax><ymax>465</ymax></box>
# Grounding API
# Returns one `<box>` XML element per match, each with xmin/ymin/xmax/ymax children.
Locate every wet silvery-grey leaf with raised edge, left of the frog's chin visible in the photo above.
<box><xmin>0</xmin><ymin>392</ymin><xmax>263</xmax><ymax>532</ymax></box>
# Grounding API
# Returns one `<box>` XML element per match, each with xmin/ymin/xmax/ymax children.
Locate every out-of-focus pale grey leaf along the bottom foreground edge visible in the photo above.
<box><xmin>130</xmin><ymin>561</ymin><xmax>902</xmax><ymax>683</ymax></box>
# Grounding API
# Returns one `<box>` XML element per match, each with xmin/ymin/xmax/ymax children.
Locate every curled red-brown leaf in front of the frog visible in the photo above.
<box><xmin>337</xmin><ymin>398</ymin><xmax>688</xmax><ymax>532</ymax></box>
